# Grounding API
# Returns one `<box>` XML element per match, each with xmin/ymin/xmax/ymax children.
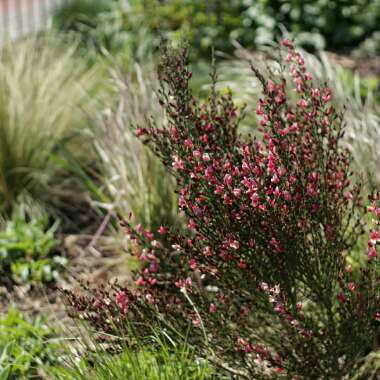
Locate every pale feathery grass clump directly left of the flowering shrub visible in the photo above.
<box><xmin>94</xmin><ymin>64</ymin><xmax>178</xmax><ymax>229</ymax></box>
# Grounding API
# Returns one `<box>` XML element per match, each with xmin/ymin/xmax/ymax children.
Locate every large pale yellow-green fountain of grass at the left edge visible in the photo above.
<box><xmin>0</xmin><ymin>37</ymin><xmax>96</xmax><ymax>211</ymax></box>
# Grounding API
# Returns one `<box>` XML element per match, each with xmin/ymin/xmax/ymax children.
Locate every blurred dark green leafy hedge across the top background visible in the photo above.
<box><xmin>52</xmin><ymin>0</ymin><xmax>380</xmax><ymax>57</ymax></box>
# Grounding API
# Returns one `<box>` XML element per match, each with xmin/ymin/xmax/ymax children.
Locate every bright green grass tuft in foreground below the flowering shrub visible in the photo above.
<box><xmin>48</xmin><ymin>320</ymin><xmax>211</xmax><ymax>380</ymax></box>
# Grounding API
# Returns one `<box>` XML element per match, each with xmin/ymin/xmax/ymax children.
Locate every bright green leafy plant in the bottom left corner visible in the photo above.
<box><xmin>0</xmin><ymin>309</ymin><xmax>58</xmax><ymax>380</ymax></box>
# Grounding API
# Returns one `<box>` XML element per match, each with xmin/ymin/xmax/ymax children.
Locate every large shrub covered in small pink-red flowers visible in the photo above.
<box><xmin>67</xmin><ymin>40</ymin><xmax>380</xmax><ymax>379</ymax></box>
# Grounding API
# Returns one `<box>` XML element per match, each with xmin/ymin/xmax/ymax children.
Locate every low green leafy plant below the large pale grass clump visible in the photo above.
<box><xmin>0</xmin><ymin>202</ymin><xmax>66</xmax><ymax>284</ymax></box>
